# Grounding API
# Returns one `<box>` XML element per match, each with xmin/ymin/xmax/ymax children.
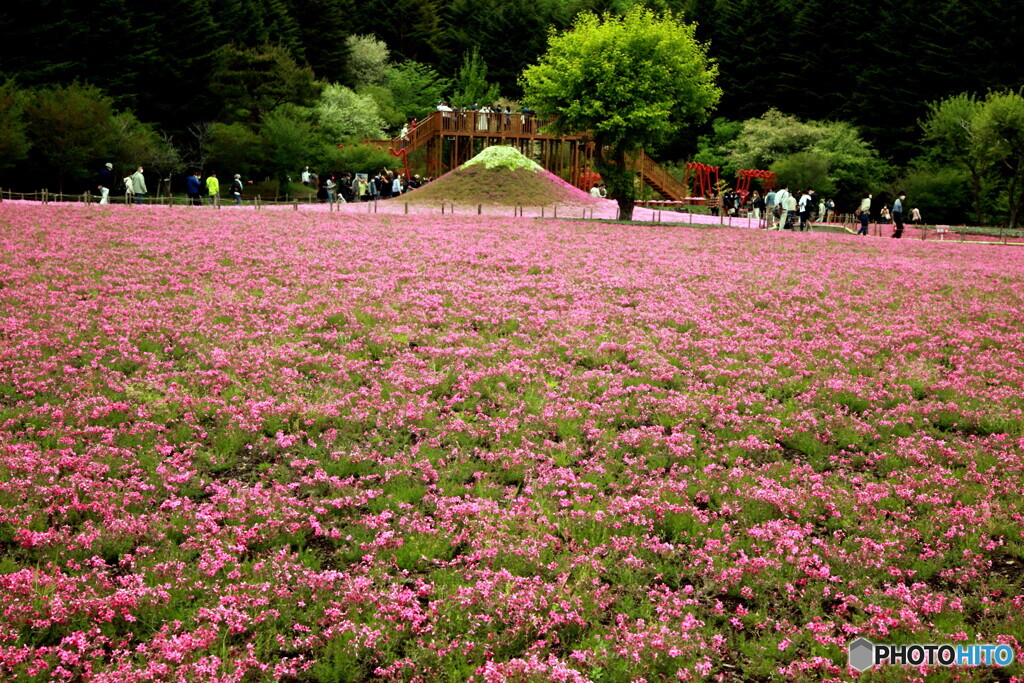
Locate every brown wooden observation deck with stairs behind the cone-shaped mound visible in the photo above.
<box><xmin>371</xmin><ymin>112</ymin><xmax>689</xmax><ymax>201</ymax></box>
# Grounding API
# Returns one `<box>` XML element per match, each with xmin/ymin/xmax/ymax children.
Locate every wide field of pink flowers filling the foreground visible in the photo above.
<box><xmin>0</xmin><ymin>202</ymin><xmax>1024</xmax><ymax>683</ymax></box>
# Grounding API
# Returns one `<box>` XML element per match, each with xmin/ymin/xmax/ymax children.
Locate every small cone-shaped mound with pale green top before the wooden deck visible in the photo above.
<box><xmin>402</xmin><ymin>146</ymin><xmax>605</xmax><ymax>207</ymax></box>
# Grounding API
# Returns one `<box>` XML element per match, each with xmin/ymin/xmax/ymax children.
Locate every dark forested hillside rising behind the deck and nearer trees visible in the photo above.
<box><xmin>0</xmin><ymin>0</ymin><xmax>1024</xmax><ymax>222</ymax></box>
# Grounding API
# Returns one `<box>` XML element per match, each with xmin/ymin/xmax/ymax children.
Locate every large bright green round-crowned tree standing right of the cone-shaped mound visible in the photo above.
<box><xmin>522</xmin><ymin>7</ymin><xmax>722</xmax><ymax>220</ymax></box>
